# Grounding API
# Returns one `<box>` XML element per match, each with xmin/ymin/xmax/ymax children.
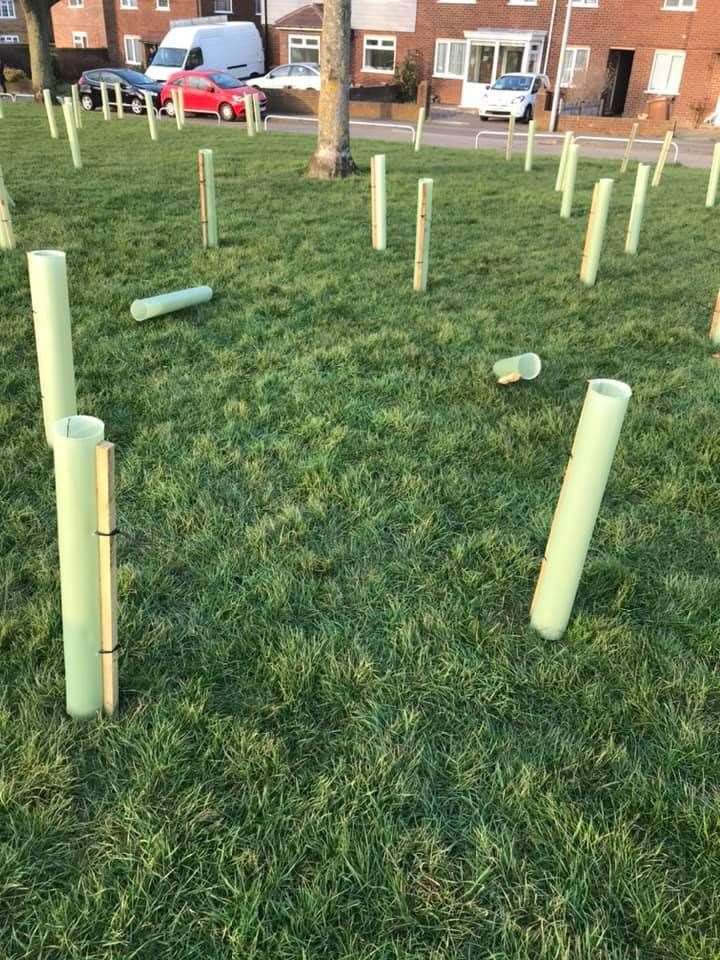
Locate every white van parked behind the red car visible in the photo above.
<box><xmin>145</xmin><ymin>21</ymin><xmax>265</xmax><ymax>81</ymax></box>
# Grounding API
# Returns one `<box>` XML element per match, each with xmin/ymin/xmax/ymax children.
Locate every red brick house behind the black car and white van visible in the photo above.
<box><xmin>53</xmin><ymin>0</ymin><xmax>262</xmax><ymax>69</ymax></box>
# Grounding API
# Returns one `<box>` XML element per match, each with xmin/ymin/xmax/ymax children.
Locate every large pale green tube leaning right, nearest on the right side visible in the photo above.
<box><xmin>530</xmin><ymin>380</ymin><xmax>632</xmax><ymax>640</ymax></box>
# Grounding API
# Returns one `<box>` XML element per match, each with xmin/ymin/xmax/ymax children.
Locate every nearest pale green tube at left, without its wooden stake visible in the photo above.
<box><xmin>53</xmin><ymin>416</ymin><xmax>105</xmax><ymax>719</ymax></box>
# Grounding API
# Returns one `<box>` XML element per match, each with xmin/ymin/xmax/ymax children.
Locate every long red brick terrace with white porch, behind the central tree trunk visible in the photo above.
<box><xmin>267</xmin><ymin>0</ymin><xmax>720</xmax><ymax>126</ymax></box>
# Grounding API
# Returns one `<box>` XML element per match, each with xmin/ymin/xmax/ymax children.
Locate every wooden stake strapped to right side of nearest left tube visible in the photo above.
<box><xmin>95</xmin><ymin>440</ymin><xmax>120</xmax><ymax>716</ymax></box>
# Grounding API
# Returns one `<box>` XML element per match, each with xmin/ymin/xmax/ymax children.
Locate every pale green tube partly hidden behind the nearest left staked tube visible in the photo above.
<box><xmin>27</xmin><ymin>250</ymin><xmax>77</xmax><ymax>446</ymax></box>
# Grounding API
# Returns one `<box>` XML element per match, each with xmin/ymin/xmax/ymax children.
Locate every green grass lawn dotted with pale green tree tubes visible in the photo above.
<box><xmin>0</xmin><ymin>105</ymin><xmax>720</xmax><ymax>960</ymax></box>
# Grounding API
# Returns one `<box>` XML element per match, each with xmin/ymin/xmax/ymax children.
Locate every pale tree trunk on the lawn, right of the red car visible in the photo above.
<box><xmin>307</xmin><ymin>0</ymin><xmax>355</xmax><ymax>180</ymax></box>
